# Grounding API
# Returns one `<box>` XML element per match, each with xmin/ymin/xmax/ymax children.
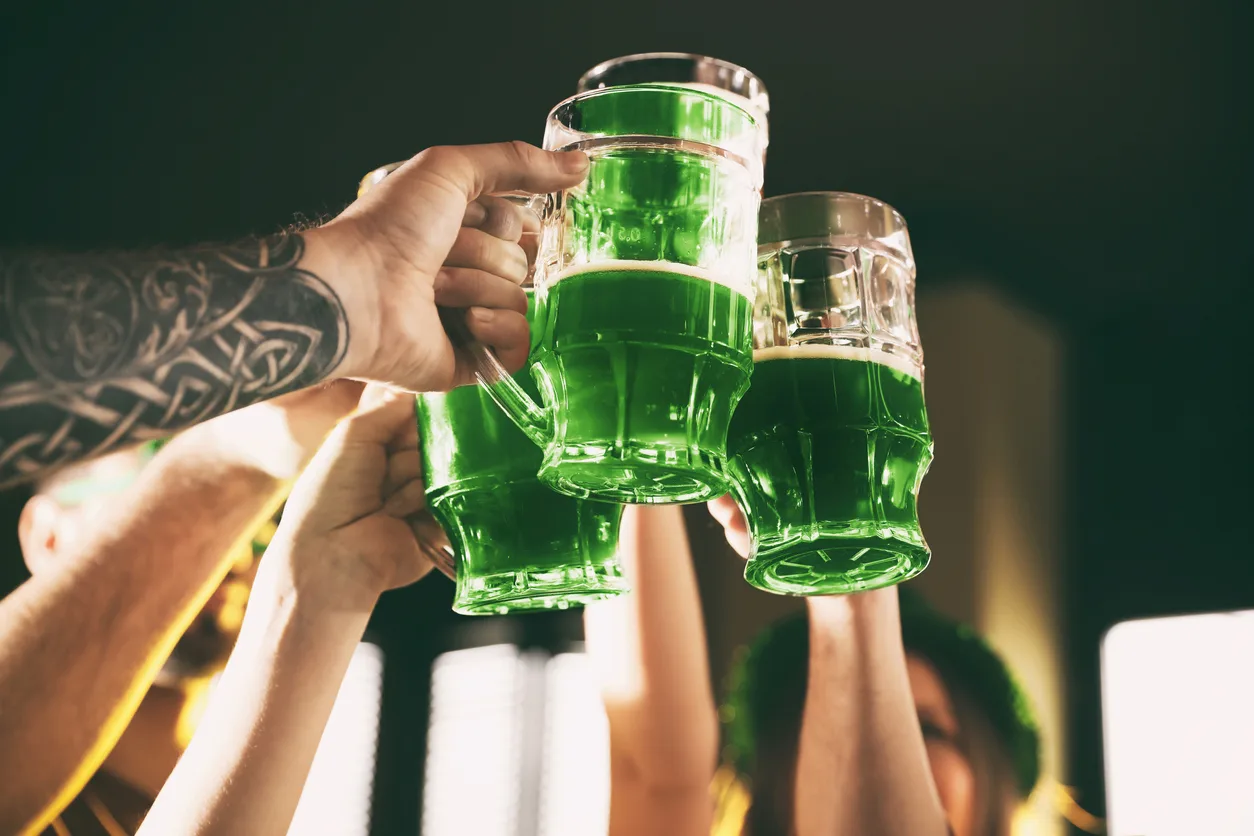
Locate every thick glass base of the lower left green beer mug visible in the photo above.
<box><xmin>453</xmin><ymin>560</ymin><xmax>631</xmax><ymax>615</ymax></box>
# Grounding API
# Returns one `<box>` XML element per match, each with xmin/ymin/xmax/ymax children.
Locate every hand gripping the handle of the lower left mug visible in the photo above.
<box><xmin>259</xmin><ymin>385</ymin><xmax>448</xmax><ymax>612</ymax></box>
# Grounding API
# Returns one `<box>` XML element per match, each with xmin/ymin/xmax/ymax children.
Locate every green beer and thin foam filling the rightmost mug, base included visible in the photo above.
<box><xmin>729</xmin><ymin>343</ymin><xmax>932</xmax><ymax>595</ymax></box>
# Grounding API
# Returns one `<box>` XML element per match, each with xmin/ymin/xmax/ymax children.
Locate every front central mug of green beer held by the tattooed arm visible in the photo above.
<box><xmin>480</xmin><ymin>84</ymin><xmax>762</xmax><ymax>503</ymax></box>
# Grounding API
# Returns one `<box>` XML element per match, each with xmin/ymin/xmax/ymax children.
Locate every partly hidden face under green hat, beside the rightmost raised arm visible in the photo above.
<box><xmin>905</xmin><ymin>656</ymin><xmax>976</xmax><ymax>836</ymax></box>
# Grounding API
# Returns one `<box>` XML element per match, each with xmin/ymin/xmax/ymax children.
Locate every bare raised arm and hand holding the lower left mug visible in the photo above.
<box><xmin>139</xmin><ymin>390</ymin><xmax>434</xmax><ymax>836</ymax></box>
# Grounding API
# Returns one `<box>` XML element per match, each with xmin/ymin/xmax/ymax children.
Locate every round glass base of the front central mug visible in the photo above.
<box><xmin>537</xmin><ymin>445</ymin><xmax>731</xmax><ymax>505</ymax></box>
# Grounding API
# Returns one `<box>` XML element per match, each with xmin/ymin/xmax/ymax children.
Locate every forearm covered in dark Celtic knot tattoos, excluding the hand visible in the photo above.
<box><xmin>0</xmin><ymin>234</ymin><xmax>349</xmax><ymax>488</ymax></box>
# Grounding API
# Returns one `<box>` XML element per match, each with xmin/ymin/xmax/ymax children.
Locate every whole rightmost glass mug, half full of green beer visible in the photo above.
<box><xmin>729</xmin><ymin>192</ymin><xmax>932</xmax><ymax>595</ymax></box>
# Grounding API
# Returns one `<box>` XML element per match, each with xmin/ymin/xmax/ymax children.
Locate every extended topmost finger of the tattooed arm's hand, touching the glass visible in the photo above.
<box><xmin>448</xmin><ymin>142</ymin><xmax>588</xmax><ymax>199</ymax></box>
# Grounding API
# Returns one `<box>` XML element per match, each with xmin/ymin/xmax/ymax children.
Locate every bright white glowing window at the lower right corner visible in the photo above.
<box><xmin>1102</xmin><ymin>610</ymin><xmax>1254</xmax><ymax>836</ymax></box>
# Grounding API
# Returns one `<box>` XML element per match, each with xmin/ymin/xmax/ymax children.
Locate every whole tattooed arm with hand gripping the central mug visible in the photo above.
<box><xmin>0</xmin><ymin>143</ymin><xmax>587</xmax><ymax>489</ymax></box>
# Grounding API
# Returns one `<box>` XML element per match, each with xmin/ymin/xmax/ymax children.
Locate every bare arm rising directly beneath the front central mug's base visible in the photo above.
<box><xmin>584</xmin><ymin>506</ymin><xmax>719</xmax><ymax>836</ymax></box>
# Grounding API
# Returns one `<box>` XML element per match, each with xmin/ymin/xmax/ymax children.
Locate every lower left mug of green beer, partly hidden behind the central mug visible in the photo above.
<box><xmin>357</xmin><ymin>171</ymin><xmax>628</xmax><ymax>615</ymax></box>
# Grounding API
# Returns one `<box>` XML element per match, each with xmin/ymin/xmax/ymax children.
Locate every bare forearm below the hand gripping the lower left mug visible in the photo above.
<box><xmin>140</xmin><ymin>555</ymin><xmax>369</xmax><ymax>836</ymax></box>
